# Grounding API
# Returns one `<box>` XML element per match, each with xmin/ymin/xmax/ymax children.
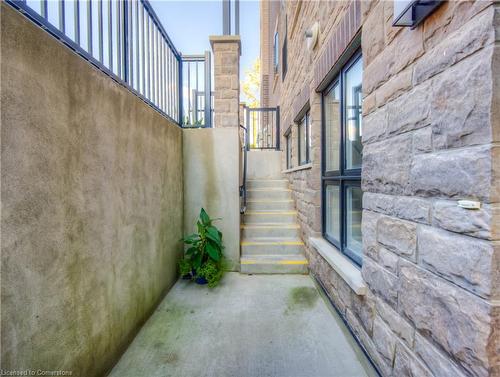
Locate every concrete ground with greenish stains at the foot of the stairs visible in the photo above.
<box><xmin>110</xmin><ymin>273</ymin><xmax>376</xmax><ymax>377</ymax></box>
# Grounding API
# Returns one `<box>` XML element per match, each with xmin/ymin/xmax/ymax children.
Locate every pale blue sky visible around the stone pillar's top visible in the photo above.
<box><xmin>150</xmin><ymin>0</ymin><xmax>260</xmax><ymax>100</ymax></box>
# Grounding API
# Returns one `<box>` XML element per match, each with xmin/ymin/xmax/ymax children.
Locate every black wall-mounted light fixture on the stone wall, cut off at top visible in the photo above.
<box><xmin>392</xmin><ymin>0</ymin><xmax>443</xmax><ymax>29</ymax></box>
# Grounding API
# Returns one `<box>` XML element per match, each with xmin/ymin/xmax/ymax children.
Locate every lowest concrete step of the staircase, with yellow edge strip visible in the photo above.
<box><xmin>241</xmin><ymin>254</ymin><xmax>307</xmax><ymax>274</ymax></box>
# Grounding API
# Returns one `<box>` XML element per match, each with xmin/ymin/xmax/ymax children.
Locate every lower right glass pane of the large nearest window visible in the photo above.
<box><xmin>346</xmin><ymin>187</ymin><xmax>363</xmax><ymax>256</ymax></box>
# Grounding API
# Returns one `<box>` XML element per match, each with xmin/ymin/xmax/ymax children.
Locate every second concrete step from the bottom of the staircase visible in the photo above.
<box><xmin>241</xmin><ymin>237</ymin><xmax>304</xmax><ymax>256</ymax></box>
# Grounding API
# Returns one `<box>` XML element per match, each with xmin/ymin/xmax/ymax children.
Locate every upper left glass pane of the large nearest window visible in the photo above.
<box><xmin>324</xmin><ymin>84</ymin><xmax>340</xmax><ymax>171</ymax></box>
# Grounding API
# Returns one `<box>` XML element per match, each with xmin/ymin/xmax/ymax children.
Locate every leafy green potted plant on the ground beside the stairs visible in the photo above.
<box><xmin>179</xmin><ymin>208</ymin><xmax>224</xmax><ymax>287</ymax></box>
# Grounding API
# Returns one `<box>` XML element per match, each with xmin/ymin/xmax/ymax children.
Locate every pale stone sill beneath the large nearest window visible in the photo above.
<box><xmin>309</xmin><ymin>237</ymin><xmax>367</xmax><ymax>296</ymax></box>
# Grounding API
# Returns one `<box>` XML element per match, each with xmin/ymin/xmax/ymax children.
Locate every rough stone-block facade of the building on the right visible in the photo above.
<box><xmin>270</xmin><ymin>1</ymin><xmax>500</xmax><ymax>376</ymax></box>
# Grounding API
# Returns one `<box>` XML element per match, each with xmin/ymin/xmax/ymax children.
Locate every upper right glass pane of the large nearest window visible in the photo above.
<box><xmin>345</xmin><ymin>59</ymin><xmax>363</xmax><ymax>169</ymax></box>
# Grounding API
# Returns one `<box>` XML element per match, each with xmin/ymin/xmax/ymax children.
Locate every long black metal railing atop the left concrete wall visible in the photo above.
<box><xmin>6</xmin><ymin>0</ymin><xmax>186</xmax><ymax>124</ymax></box>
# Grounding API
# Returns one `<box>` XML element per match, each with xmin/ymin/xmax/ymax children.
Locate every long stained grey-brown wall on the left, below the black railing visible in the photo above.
<box><xmin>1</xmin><ymin>3</ymin><xmax>183</xmax><ymax>377</ymax></box>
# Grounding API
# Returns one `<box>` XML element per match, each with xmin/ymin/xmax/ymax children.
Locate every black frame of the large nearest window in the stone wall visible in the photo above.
<box><xmin>321</xmin><ymin>49</ymin><xmax>363</xmax><ymax>266</ymax></box>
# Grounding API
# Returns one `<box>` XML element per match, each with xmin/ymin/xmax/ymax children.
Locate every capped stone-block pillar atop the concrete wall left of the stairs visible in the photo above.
<box><xmin>210</xmin><ymin>35</ymin><xmax>241</xmax><ymax>127</ymax></box>
